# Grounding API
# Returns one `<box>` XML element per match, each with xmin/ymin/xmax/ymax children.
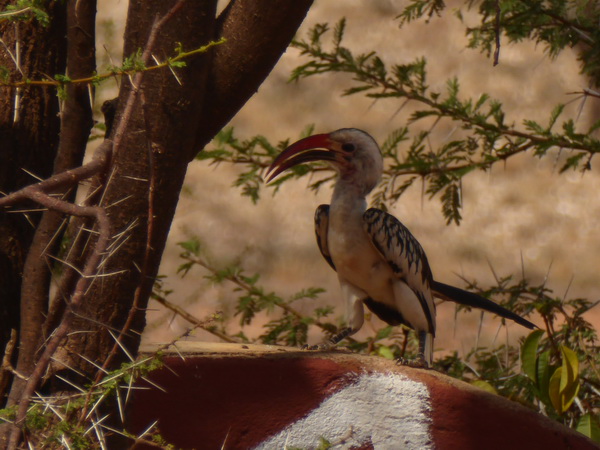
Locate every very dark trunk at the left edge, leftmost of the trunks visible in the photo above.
<box><xmin>0</xmin><ymin>0</ymin><xmax>66</xmax><ymax>404</ymax></box>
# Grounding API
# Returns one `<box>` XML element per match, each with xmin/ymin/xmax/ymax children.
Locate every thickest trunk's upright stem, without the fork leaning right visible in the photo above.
<box><xmin>51</xmin><ymin>0</ymin><xmax>216</xmax><ymax>408</ymax></box>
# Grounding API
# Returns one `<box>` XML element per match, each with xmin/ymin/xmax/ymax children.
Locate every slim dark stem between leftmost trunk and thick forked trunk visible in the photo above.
<box><xmin>9</xmin><ymin>0</ymin><xmax>96</xmax><ymax>412</ymax></box>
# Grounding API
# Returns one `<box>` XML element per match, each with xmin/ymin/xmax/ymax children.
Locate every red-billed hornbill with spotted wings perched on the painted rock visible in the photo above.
<box><xmin>268</xmin><ymin>128</ymin><xmax>536</xmax><ymax>366</ymax></box>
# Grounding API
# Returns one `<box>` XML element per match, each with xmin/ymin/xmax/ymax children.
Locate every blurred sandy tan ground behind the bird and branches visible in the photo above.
<box><xmin>98</xmin><ymin>0</ymin><xmax>600</xmax><ymax>351</ymax></box>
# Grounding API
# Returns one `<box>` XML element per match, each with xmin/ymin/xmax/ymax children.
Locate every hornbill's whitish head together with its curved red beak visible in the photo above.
<box><xmin>268</xmin><ymin>128</ymin><xmax>383</xmax><ymax>195</ymax></box>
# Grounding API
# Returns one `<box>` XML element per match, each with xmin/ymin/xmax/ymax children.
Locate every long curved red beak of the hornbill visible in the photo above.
<box><xmin>267</xmin><ymin>134</ymin><xmax>340</xmax><ymax>182</ymax></box>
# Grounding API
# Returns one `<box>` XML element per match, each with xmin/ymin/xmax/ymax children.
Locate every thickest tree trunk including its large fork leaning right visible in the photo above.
<box><xmin>52</xmin><ymin>0</ymin><xmax>312</xmax><ymax>380</ymax></box>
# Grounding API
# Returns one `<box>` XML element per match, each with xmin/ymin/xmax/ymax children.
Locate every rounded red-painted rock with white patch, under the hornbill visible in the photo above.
<box><xmin>127</xmin><ymin>342</ymin><xmax>598</xmax><ymax>450</ymax></box>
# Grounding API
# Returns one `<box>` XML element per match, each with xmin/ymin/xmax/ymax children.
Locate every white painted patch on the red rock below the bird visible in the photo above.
<box><xmin>257</xmin><ymin>373</ymin><xmax>433</xmax><ymax>450</ymax></box>
